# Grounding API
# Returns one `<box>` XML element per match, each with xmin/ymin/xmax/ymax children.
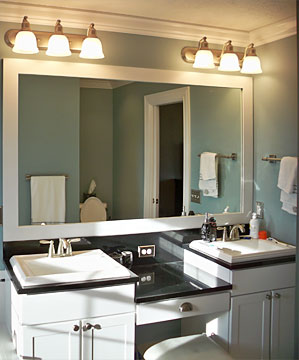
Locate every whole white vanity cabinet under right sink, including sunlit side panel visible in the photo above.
<box><xmin>184</xmin><ymin>250</ymin><xmax>296</xmax><ymax>360</ymax></box>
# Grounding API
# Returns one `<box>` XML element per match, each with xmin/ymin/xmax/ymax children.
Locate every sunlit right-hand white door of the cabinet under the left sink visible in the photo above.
<box><xmin>82</xmin><ymin>313</ymin><xmax>135</xmax><ymax>360</ymax></box>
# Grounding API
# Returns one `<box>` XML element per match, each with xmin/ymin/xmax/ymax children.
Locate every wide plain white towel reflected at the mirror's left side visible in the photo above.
<box><xmin>31</xmin><ymin>176</ymin><xmax>65</xmax><ymax>224</ymax></box>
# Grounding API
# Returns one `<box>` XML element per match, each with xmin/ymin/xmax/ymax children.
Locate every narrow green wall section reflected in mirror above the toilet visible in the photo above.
<box><xmin>80</xmin><ymin>88</ymin><xmax>113</xmax><ymax>218</ymax></box>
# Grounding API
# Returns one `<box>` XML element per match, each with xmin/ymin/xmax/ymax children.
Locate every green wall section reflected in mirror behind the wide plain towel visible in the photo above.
<box><xmin>19</xmin><ymin>75</ymin><xmax>80</xmax><ymax>225</ymax></box>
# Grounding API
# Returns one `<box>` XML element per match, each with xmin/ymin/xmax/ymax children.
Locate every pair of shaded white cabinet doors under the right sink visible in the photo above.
<box><xmin>229</xmin><ymin>287</ymin><xmax>295</xmax><ymax>360</ymax></box>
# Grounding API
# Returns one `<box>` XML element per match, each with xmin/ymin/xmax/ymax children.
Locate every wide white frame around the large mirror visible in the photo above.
<box><xmin>3</xmin><ymin>59</ymin><xmax>253</xmax><ymax>241</ymax></box>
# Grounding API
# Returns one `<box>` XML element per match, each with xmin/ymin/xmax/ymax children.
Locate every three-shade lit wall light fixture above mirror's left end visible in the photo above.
<box><xmin>4</xmin><ymin>16</ymin><xmax>104</xmax><ymax>59</ymax></box>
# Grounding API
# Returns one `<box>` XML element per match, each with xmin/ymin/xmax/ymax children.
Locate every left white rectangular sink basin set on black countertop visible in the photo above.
<box><xmin>9</xmin><ymin>250</ymin><xmax>130</xmax><ymax>287</ymax></box>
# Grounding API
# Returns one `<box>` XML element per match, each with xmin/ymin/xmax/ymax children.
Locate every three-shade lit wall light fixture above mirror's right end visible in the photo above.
<box><xmin>181</xmin><ymin>37</ymin><xmax>262</xmax><ymax>74</ymax></box>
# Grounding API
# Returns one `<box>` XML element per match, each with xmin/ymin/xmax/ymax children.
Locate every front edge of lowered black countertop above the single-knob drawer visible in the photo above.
<box><xmin>135</xmin><ymin>284</ymin><xmax>233</xmax><ymax>304</ymax></box>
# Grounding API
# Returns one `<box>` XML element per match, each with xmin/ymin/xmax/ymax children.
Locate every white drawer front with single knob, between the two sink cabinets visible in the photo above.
<box><xmin>136</xmin><ymin>292</ymin><xmax>230</xmax><ymax>325</ymax></box>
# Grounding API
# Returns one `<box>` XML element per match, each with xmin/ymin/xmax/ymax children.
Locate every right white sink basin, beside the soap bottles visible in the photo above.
<box><xmin>189</xmin><ymin>239</ymin><xmax>296</xmax><ymax>263</ymax></box>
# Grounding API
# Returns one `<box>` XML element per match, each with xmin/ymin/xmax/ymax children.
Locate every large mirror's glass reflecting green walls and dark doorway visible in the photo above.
<box><xmin>18</xmin><ymin>75</ymin><xmax>241</xmax><ymax>225</ymax></box>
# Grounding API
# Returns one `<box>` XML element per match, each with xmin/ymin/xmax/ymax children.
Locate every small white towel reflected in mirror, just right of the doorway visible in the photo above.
<box><xmin>198</xmin><ymin>152</ymin><xmax>218</xmax><ymax>198</ymax></box>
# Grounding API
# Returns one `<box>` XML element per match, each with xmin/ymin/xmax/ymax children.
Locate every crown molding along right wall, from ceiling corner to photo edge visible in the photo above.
<box><xmin>249</xmin><ymin>16</ymin><xmax>297</xmax><ymax>46</ymax></box>
